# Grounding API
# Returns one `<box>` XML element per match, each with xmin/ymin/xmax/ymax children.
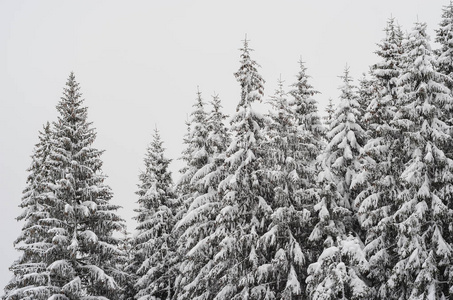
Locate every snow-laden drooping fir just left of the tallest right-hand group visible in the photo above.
<box><xmin>307</xmin><ymin>68</ymin><xmax>371</xmax><ymax>299</ymax></box>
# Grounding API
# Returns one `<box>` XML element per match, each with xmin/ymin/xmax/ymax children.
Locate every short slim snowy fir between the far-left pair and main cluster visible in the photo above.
<box><xmin>130</xmin><ymin>129</ymin><xmax>175</xmax><ymax>300</ymax></box>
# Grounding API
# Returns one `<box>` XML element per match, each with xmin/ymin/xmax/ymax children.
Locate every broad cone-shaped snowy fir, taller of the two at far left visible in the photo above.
<box><xmin>5</xmin><ymin>73</ymin><xmax>125</xmax><ymax>300</ymax></box>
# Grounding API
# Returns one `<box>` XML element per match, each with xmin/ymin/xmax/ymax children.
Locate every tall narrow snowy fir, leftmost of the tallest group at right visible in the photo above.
<box><xmin>356</xmin><ymin>18</ymin><xmax>403</xmax><ymax>298</ymax></box>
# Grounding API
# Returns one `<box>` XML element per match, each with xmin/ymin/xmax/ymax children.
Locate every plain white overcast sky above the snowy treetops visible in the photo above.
<box><xmin>0</xmin><ymin>0</ymin><xmax>448</xmax><ymax>295</ymax></box>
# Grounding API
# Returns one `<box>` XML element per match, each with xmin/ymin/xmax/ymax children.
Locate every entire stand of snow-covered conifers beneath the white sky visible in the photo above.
<box><xmin>7</xmin><ymin>2</ymin><xmax>453</xmax><ymax>300</ymax></box>
